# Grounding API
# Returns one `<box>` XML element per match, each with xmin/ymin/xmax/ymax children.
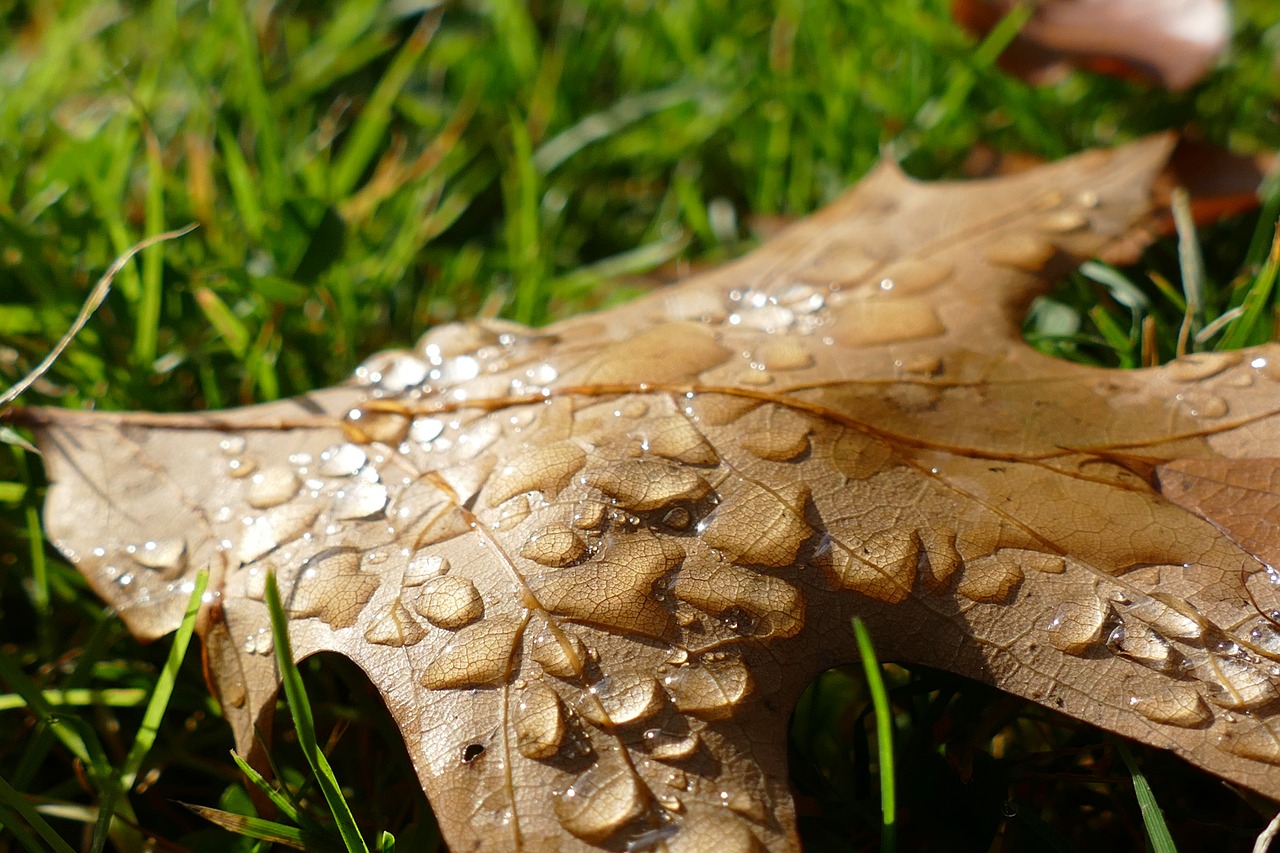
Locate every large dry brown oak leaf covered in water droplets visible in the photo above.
<box><xmin>17</xmin><ymin>138</ymin><xmax>1280</xmax><ymax>852</ymax></box>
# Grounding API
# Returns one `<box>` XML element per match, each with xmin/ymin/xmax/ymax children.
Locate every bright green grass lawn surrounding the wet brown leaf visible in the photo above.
<box><xmin>0</xmin><ymin>0</ymin><xmax>1280</xmax><ymax>850</ymax></box>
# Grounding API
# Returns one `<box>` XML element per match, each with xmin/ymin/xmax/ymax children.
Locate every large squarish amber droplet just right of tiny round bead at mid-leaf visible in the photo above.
<box><xmin>701</xmin><ymin>482</ymin><xmax>813</xmax><ymax>567</ymax></box>
